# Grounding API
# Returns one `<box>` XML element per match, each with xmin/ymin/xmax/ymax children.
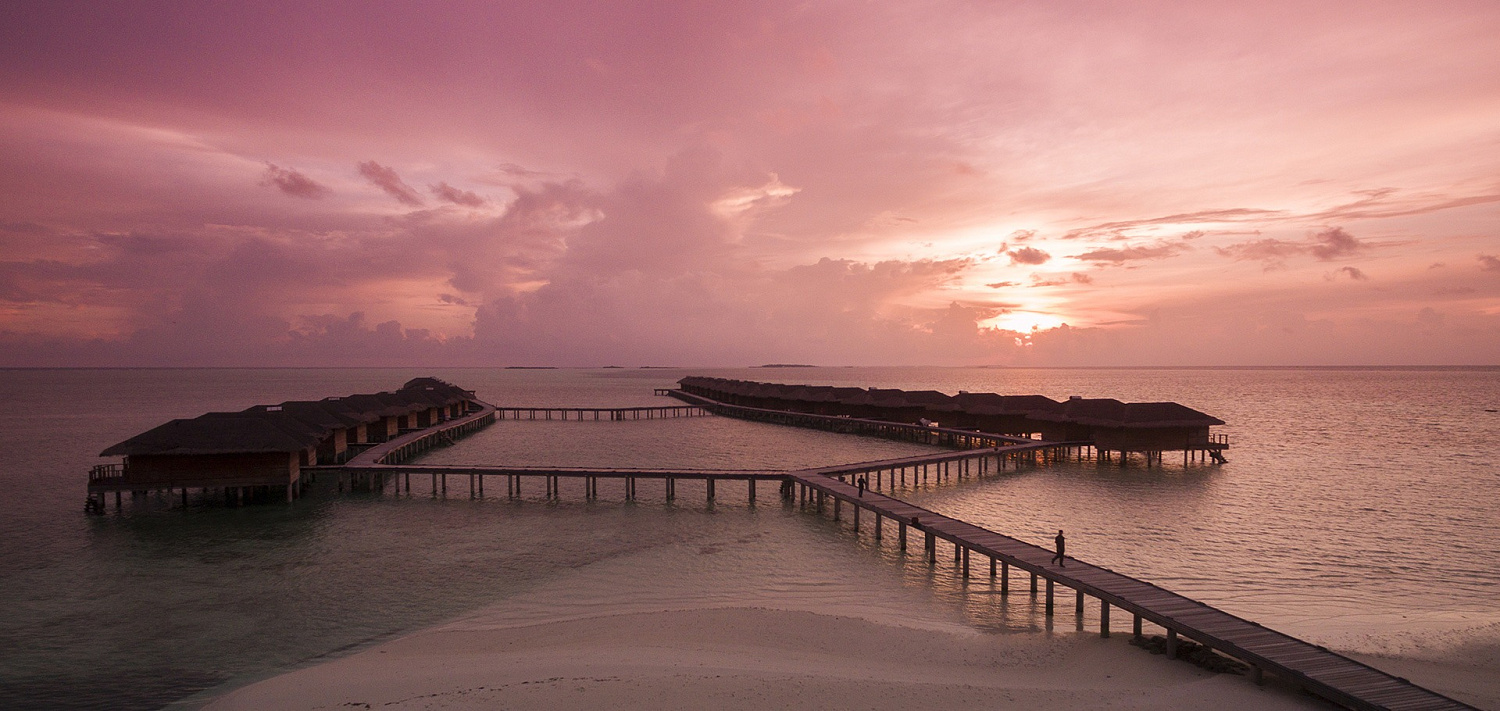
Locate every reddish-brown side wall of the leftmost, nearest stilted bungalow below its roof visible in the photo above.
<box><xmin>125</xmin><ymin>452</ymin><xmax>302</xmax><ymax>486</ymax></box>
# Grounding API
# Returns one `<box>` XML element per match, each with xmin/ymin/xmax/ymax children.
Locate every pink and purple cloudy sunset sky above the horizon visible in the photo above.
<box><xmin>0</xmin><ymin>0</ymin><xmax>1500</xmax><ymax>366</ymax></box>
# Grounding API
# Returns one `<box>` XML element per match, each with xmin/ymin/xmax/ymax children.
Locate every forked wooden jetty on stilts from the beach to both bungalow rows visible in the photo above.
<box><xmin>334</xmin><ymin>392</ymin><xmax>1473</xmax><ymax>711</ymax></box>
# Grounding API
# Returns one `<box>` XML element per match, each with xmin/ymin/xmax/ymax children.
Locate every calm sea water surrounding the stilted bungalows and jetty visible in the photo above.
<box><xmin>0</xmin><ymin>368</ymin><xmax>1500</xmax><ymax>710</ymax></box>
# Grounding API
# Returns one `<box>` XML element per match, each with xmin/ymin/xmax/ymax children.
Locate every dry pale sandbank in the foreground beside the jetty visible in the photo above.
<box><xmin>209</xmin><ymin>608</ymin><xmax>1326</xmax><ymax>711</ymax></box>
